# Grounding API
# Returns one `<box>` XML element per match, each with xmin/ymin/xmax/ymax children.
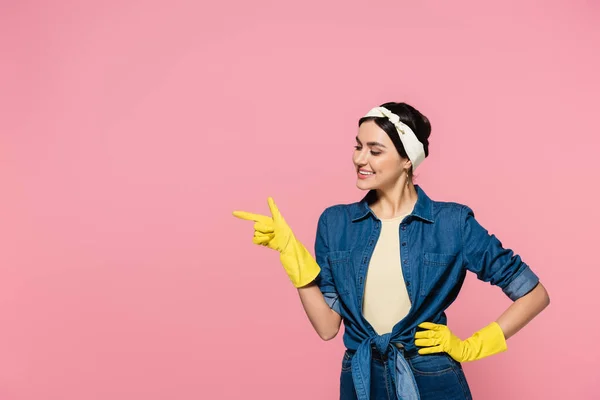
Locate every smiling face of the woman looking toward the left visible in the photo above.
<box><xmin>352</xmin><ymin>121</ymin><xmax>410</xmax><ymax>190</ymax></box>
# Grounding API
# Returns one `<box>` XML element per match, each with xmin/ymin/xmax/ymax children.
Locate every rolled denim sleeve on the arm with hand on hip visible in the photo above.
<box><xmin>462</xmin><ymin>206</ymin><xmax>539</xmax><ymax>301</ymax></box>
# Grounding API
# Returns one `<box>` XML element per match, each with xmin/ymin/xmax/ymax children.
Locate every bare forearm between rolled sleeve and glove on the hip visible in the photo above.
<box><xmin>496</xmin><ymin>283</ymin><xmax>550</xmax><ymax>339</ymax></box>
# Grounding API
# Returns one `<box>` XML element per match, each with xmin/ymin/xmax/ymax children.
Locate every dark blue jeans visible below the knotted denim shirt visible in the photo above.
<box><xmin>340</xmin><ymin>349</ymin><xmax>472</xmax><ymax>400</ymax></box>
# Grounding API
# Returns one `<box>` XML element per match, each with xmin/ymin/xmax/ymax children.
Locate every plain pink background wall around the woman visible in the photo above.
<box><xmin>0</xmin><ymin>0</ymin><xmax>600</xmax><ymax>400</ymax></box>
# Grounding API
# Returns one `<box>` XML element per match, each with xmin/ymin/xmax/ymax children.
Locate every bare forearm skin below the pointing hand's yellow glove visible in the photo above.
<box><xmin>298</xmin><ymin>283</ymin><xmax>342</xmax><ymax>340</ymax></box>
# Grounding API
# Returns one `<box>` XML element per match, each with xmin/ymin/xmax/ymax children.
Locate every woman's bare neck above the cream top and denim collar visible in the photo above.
<box><xmin>371</xmin><ymin>181</ymin><xmax>418</xmax><ymax>219</ymax></box>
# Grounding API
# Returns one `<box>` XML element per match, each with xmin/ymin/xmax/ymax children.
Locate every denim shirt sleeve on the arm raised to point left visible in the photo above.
<box><xmin>315</xmin><ymin>210</ymin><xmax>340</xmax><ymax>314</ymax></box>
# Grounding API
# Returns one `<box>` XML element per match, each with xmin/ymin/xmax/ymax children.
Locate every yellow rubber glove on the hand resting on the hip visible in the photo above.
<box><xmin>415</xmin><ymin>322</ymin><xmax>507</xmax><ymax>362</ymax></box>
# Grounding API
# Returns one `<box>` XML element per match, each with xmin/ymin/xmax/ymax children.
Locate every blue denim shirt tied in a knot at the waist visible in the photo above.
<box><xmin>315</xmin><ymin>186</ymin><xmax>539</xmax><ymax>400</ymax></box>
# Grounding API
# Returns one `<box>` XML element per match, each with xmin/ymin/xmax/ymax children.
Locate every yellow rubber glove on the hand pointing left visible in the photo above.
<box><xmin>233</xmin><ymin>197</ymin><xmax>321</xmax><ymax>288</ymax></box>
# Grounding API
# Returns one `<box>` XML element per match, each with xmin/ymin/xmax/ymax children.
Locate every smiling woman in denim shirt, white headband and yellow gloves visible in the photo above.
<box><xmin>234</xmin><ymin>103</ymin><xmax>549</xmax><ymax>400</ymax></box>
